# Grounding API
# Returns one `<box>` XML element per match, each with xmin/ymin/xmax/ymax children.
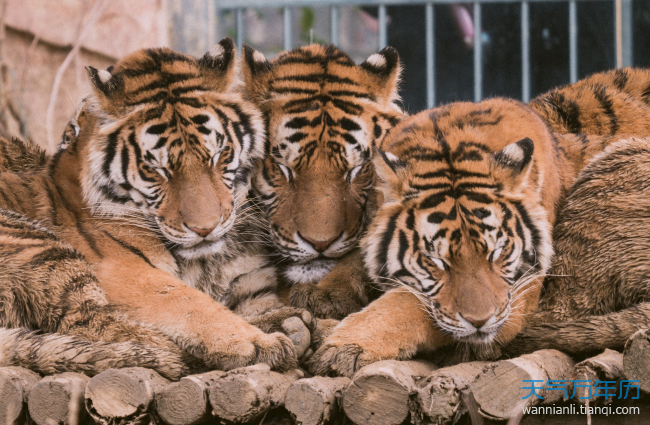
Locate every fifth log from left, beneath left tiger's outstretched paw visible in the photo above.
<box><xmin>209</xmin><ymin>364</ymin><xmax>304</xmax><ymax>423</ymax></box>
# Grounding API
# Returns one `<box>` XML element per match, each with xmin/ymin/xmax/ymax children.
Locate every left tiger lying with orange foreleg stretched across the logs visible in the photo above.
<box><xmin>0</xmin><ymin>38</ymin><xmax>307</xmax><ymax>378</ymax></box>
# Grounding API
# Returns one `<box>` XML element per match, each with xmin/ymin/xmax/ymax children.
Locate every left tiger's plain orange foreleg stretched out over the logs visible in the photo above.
<box><xmin>95</xmin><ymin>255</ymin><xmax>298</xmax><ymax>370</ymax></box>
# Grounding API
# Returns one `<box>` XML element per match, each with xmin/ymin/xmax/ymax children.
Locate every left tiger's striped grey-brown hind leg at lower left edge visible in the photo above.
<box><xmin>0</xmin><ymin>210</ymin><xmax>197</xmax><ymax>379</ymax></box>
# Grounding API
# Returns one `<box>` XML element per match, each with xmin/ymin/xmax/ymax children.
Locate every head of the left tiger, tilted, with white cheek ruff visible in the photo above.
<box><xmin>78</xmin><ymin>38</ymin><xmax>264</xmax><ymax>258</ymax></box>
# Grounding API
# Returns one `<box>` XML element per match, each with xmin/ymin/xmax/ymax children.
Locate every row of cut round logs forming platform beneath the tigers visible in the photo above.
<box><xmin>5</xmin><ymin>344</ymin><xmax>650</xmax><ymax>425</ymax></box>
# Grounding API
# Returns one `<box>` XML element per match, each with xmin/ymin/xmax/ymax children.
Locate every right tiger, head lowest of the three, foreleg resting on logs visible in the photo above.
<box><xmin>309</xmin><ymin>69</ymin><xmax>650</xmax><ymax>376</ymax></box>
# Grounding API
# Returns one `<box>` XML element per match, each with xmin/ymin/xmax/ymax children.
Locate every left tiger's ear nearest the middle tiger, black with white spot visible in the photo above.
<box><xmin>199</xmin><ymin>37</ymin><xmax>237</xmax><ymax>91</ymax></box>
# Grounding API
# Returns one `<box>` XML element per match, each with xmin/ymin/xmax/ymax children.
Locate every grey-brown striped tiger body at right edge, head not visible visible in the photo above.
<box><xmin>503</xmin><ymin>137</ymin><xmax>650</xmax><ymax>359</ymax></box>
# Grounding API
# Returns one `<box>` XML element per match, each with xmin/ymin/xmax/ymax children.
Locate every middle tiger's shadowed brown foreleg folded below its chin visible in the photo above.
<box><xmin>289</xmin><ymin>250</ymin><xmax>370</xmax><ymax>320</ymax></box>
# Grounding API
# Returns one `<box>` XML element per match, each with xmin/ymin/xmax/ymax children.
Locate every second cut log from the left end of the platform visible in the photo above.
<box><xmin>29</xmin><ymin>372</ymin><xmax>90</xmax><ymax>425</ymax></box>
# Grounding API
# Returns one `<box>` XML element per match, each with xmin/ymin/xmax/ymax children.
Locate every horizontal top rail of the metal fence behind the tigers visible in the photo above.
<box><xmin>219</xmin><ymin>0</ymin><xmax>612</xmax><ymax>9</ymax></box>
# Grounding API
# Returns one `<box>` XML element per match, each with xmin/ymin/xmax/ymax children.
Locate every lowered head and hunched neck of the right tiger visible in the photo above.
<box><xmin>362</xmin><ymin>99</ymin><xmax>561</xmax><ymax>345</ymax></box>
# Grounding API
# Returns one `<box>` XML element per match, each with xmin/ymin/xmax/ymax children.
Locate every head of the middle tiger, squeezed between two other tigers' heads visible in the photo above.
<box><xmin>242</xmin><ymin>45</ymin><xmax>403</xmax><ymax>283</ymax></box>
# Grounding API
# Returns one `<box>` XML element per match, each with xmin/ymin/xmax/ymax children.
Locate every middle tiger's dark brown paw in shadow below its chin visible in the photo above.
<box><xmin>289</xmin><ymin>283</ymin><xmax>363</xmax><ymax>320</ymax></box>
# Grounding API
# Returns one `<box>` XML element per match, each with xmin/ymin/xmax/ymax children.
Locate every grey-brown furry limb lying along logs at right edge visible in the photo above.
<box><xmin>504</xmin><ymin>302</ymin><xmax>650</xmax><ymax>356</ymax></box>
